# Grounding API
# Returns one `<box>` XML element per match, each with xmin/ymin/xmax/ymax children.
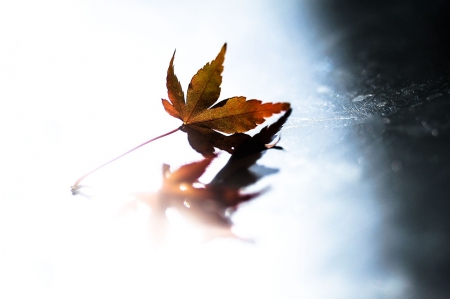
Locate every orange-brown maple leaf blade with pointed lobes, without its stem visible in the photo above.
<box><xmin>162</xmin><ymin>44</ymin><xmax>290</xmax><ymax>156</ymax></box>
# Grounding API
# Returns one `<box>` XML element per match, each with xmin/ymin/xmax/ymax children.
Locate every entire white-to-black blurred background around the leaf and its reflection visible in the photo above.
<box><xmin>0</xmin><ymin>0</ymin><xmax>450</xmax><ymax>299</ymax></box>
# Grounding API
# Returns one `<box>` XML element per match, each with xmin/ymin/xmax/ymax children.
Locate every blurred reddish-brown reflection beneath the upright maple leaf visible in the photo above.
<box><xmin>125</xmin><ymin>110</ymin><xmax>291</xmax><ymax>243</ymax></box>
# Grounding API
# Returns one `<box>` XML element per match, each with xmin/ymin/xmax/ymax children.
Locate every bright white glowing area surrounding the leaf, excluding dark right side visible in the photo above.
<box><xmin>0</xmin><ymin>0</ymin><xmax>407</xmax><ymax>299</ymax></box>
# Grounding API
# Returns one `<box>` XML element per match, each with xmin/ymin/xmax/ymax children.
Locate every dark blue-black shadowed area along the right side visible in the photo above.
<box><xmin>313</xmin><ymin>0</ymin><xmax>450</xmax><ymax>298</ymax></box>
